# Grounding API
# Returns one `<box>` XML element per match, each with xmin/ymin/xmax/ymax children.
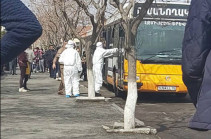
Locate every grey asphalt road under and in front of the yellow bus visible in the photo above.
<box><xmin>103</xmin><ymin>89</ymin><xmax>211</xmax><ymax>139</ymax></box>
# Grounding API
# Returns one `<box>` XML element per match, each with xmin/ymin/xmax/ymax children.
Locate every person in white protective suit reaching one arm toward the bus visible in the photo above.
<box><xmin>92</xmin><ymin>42</ymin><xmax>118</xmax><ymax>93</ymax></box>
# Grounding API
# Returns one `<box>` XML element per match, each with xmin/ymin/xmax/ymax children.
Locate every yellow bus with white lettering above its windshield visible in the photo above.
<box><xmin>102</xmin><ymin>3</ymin><xmax>189</xmax><ymax>97</ymax></box>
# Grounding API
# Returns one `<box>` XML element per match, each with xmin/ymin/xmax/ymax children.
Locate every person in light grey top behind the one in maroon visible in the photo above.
<box><xmin>25</xmin><ymin>46</ymin><xmax>35</xmax><ymax>79</ymax></box>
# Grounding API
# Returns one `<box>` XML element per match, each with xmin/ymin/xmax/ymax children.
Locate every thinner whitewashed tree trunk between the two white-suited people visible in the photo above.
<box><xmin>86</xmin><ymin>42</ymin><xmax>95</xmax><ymax>98</ymax></box>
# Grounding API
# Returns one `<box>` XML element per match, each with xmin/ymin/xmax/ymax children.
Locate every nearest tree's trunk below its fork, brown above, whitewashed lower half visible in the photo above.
<box><xmin>124</xmin><ymin>23</ymin><xmax>138</xmax><ymax>130</ymax></box>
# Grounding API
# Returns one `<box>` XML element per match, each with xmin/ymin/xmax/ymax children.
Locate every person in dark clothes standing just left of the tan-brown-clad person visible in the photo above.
<box><xmin>44</xmin><ymin>45</ymin><xmax>56</xmax><ymax>79</ymax></box>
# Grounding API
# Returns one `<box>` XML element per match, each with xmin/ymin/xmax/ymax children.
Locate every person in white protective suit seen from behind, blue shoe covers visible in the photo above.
<box><xmin>59</xmin><ymin>40</ymin><xmax>82</xmax><ymax>96</ymax></box>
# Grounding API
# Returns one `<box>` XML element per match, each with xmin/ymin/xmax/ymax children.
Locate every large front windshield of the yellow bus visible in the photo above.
<box><xmin>135</xmin><ymin>21</ymin><xmax>185</xmax><ymax>64</ymax></box>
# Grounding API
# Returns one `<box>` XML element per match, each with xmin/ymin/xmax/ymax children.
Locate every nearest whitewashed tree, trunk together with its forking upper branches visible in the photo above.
<box><xmin>110</xmin><ymin>0</ymin><xmax>153</xmax><ymax>130</ymax></box>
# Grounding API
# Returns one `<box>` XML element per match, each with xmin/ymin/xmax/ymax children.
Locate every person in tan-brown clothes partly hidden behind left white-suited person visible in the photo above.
<box><xmin>53</xmin><ymin>41</ymin><xmax>67</xmax><ymax>95</ymax></box>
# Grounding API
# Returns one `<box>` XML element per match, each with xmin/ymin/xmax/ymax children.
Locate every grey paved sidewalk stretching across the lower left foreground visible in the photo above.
<box><xmin>1</xmin><ymin>73</ymin><xmax>158</xmax><ymax>139</ymax></box>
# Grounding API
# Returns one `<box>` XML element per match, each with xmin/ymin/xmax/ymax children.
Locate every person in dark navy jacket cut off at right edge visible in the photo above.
<box><xmin>182</xmin><ymin>0</ymin><xmax>211</xmax><ymax>130</ymax></box>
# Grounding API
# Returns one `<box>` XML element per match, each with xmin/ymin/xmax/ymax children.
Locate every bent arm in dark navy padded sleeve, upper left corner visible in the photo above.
<box><xmin>1</xmin><ymin>0</ymin><xmax>42</xmax><ymax>65</ymax></box>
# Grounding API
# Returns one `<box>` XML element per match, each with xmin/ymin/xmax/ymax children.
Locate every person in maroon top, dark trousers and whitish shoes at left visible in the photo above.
<box><xmin>18</xmin><ymin>52</ymin><xmax>28</xmax><ymax>92</ymax></box>
